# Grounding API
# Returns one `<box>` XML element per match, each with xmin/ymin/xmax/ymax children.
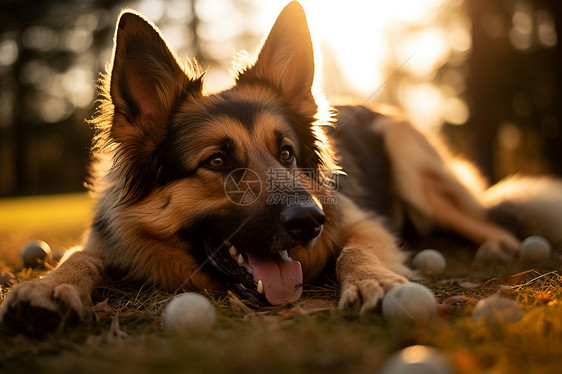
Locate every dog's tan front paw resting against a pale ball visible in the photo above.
<box><xmin>338</xmin><ymin>272</ymin><xmax>408</xmax><ymax>314</ymax></box>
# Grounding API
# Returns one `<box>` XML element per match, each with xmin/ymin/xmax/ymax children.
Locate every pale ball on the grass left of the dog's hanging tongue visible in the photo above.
<box><xmin>162</xmin><ymin>292</ymin><xmax>217</xmax><ymax>335</ymax></box>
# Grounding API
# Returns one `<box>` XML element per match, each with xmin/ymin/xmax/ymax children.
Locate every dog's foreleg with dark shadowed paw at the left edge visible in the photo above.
<box><xmin>0</xmin><ymin>247</ymin><xmax>103</xmax><ymax>329</ymax></box>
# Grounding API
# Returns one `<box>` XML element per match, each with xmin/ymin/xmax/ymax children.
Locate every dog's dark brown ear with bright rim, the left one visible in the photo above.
<box><xmin>110</xmin><ymin>11</ymin><xmax>201</xmax><ymax>148</ymax></box>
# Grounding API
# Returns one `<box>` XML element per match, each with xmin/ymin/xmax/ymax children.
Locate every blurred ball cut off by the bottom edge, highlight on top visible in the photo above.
<box><xmin>380</xmin><ymin>345</ymin><xmax>454</xmax><ymax>374</ymax></box>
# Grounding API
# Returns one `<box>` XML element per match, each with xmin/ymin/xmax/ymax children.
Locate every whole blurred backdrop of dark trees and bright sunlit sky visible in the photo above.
<box><xmin>0</xmin><ymin>0</ymin><xmax>562</xmax><ymax>196</ymax></box>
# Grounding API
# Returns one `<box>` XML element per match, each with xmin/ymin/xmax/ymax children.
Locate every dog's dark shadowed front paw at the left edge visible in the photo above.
<box><xmin>0</xmin><ymin>280</ymin><xmax>92</xmax><ymax>330</ymax></box>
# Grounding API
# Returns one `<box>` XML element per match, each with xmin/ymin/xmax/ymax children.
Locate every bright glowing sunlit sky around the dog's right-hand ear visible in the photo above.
<box><xmin>252</xmin><ymin>0</ymin><xmax>471</xmax><ymax>130</ymax></box>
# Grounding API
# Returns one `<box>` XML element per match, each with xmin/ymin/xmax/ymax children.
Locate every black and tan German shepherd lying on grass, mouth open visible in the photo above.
<box><xmin>0</xmin><ymin>2</ymin><xmax>562</xmax><ymax>327</ymax></box>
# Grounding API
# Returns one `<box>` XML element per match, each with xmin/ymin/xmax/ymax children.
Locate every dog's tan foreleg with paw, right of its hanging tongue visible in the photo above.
<box><xmin>336</xmin><ymin>196</ymin><xmax>410</xmax><ymax>313</ymax></box>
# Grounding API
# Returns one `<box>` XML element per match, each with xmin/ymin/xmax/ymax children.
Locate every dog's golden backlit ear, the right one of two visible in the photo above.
<box><xmin>238</xmin><ymin>1</ymin><xmax>316</xmax><ymax>115</ymax></box>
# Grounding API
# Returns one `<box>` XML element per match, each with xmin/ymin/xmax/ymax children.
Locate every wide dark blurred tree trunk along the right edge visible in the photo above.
<box><xmin>466</xmin><ymin>0</ymin><xmax>562</xmax><ymax>181</ymax></box>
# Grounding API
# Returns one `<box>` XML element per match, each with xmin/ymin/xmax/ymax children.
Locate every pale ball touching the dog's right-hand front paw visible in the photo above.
<box><xmin>382</xmin><ymin>283</ymin><xmax>437</xmax><ymax>323</ymax></box>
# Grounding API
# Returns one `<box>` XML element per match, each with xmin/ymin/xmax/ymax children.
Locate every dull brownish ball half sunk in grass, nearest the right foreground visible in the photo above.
<box><xmin>472</xmin><ymin>295</ymin><xmax>525</xmax><ymax>326</ymax></box>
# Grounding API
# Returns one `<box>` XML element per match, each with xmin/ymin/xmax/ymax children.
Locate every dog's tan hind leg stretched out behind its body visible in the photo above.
<box><xmin>376</xmin><ymin>119</ymin><xmax>520</xmax><ymax>261</ymax></box>
